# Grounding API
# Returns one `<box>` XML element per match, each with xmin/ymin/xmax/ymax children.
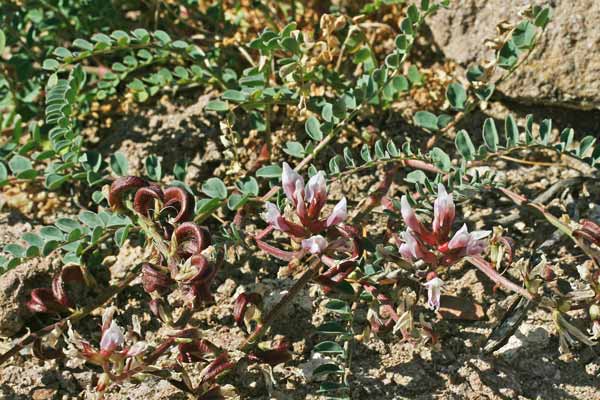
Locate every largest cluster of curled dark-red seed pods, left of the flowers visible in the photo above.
<box><xmin>109</xmin><ymin>176</ymin><xmax>219</xmax><ymax>304</ymax></box>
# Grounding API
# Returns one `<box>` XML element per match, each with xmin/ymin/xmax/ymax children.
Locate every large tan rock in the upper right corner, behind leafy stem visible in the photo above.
<box><xmin>429</xmin><ymin>0</ymin><xmax>600</xmax><ymax>109</ymax></box>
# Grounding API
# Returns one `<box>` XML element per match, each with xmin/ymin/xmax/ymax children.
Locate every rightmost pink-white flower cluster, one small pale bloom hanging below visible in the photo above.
<box><xmin>398</xmin><ymin>184</ymin><xmax>491</xmax><ymax>310</ymax></box>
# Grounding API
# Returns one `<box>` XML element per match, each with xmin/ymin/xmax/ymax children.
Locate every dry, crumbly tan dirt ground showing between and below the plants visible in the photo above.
<box><xmin>0</xmin><ymin>97</ymin><xmax>600</xmax><ymax>400</ymax></box>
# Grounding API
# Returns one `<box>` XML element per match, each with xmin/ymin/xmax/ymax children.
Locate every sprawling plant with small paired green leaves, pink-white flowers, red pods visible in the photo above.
<box><xmin>0</xmin><ymin>0</ymin><xmax>600</xmax><ymax>400</ymax></box>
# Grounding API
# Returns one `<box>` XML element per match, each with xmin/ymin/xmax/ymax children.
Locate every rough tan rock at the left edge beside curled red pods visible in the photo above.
<box><xmin>0</xmin><ymin>259</ymin><xmax>52</xmax><ymax>336</ymax></box>
